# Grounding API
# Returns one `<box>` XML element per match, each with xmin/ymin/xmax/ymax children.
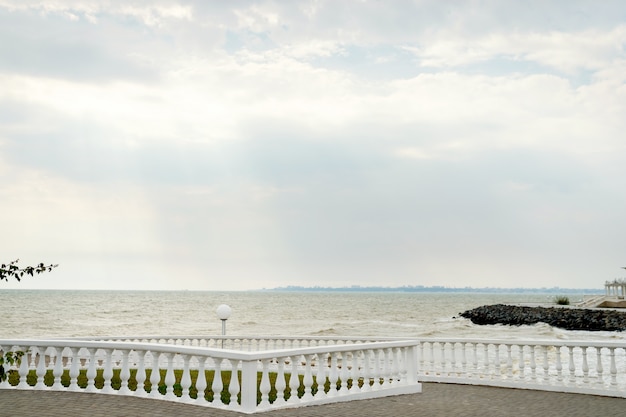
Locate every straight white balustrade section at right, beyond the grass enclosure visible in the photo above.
<box><xmin>418</xmin><ymin>339</ymin><xmax>626</xmax><ymax>398</ymax></box>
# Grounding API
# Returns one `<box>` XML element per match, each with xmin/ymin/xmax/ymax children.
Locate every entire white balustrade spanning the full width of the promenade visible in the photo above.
<box><xmin>0</xmin><ymin>336</ymin><xmax>626</xmax><ymax>413</ymax></box>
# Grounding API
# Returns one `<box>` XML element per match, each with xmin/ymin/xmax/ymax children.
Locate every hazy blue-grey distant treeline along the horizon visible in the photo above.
<box><xmin>262</xmin><ymin>285</ymin><xmax>604</xmax><ymax>294</ymax></box>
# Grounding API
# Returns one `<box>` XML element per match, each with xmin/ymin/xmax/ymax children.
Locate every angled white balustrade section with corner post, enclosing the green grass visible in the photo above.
<box><xmin>0</xmin><ymin>337</ymin><xmax>421</xmax><ymax>413</ymax></box>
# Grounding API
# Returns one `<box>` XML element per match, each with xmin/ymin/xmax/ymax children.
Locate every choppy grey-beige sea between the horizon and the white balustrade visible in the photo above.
<box><xmin>0</xmin><ymin>290</ymin><xmax>626</xmax><ymax>341</ymax></box>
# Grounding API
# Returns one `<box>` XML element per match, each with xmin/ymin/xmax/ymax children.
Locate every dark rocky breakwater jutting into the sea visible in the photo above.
<box><xmin>460</xmin><ymin>304</ymin><xmax>626</xmax><ymax>331</ymax></box>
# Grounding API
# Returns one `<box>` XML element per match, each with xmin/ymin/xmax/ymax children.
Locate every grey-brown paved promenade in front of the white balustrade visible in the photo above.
<box><xmin>0</xmin><ymin>383</ymin><xmax>626</xmax><ymax>417</ymax></box>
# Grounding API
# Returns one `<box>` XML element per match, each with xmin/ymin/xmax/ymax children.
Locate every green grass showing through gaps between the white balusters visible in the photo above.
<box><xmin>3</xmin><ymin>369</ymin><xmax>352</xmax><ymax>404</ymax></box>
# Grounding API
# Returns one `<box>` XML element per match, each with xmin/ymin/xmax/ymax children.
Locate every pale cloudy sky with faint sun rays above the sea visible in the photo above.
<box><xmin>0</xmin><ymin>0</ymin><xmax>626</xmax><ymax>291</ymax></box>
